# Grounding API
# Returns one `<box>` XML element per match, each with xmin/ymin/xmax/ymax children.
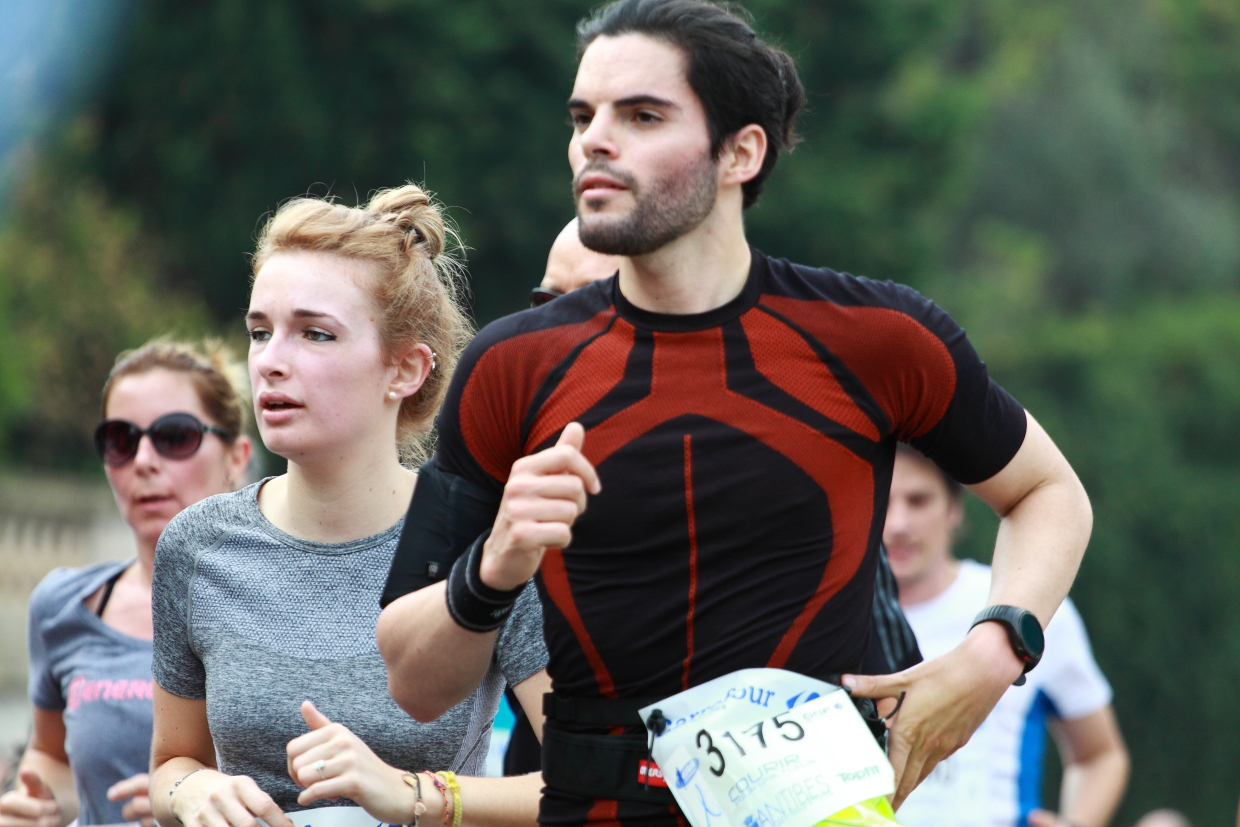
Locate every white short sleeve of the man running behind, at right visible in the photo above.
<box><xmin>1029</xmin><ymin>599</ymin><xmax>1111</xmax><ymax>720</ymax></box>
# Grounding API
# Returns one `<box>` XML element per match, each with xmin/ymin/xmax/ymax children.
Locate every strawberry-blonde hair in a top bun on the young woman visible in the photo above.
<box><xmin>253</xmin><ymin>184</ymin><xmax>472</xmax><ymax>462</ymax></box>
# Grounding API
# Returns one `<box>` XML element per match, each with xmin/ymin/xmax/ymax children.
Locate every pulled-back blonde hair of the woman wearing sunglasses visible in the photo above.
<box><xmin>102</xmin><ymin>336</ymin><xmax>249</xmax><ymax>444</ymax></box>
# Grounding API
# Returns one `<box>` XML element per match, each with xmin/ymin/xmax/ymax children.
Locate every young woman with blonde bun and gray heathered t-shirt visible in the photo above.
<box><xmin>151</xmin><ymin>185</ymin><xmax>549</xmax><ymax>827</ymax></box>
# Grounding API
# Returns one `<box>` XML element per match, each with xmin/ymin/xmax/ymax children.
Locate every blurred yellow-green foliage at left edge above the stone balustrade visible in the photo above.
<box><xmin>0</xmin><ymin>123</ymin><xmax>208</xmax><ymax>472</ymax></box>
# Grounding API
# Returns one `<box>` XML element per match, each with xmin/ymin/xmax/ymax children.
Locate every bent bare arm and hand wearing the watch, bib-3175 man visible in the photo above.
<box><xmin>844</xmin><ymin>414</ymin><xmax>1092</xmax><ymax>807</ymax></box>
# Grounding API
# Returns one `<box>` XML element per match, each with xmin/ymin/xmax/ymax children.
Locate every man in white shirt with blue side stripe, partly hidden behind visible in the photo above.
<box><xmin>883</xmin><ymin>445</ymin><xmax>1128</xmax><ymax>827</ymax></box>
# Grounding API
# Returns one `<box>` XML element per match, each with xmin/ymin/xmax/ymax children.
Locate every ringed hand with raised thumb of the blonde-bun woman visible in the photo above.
<box><xmin>287</xmin><ymin>701</ymin><xmax>429</xmax><ymax>827</ymax></box>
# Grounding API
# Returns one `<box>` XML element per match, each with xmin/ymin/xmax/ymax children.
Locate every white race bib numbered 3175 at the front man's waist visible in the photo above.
<box><xmin>639</xmin><ymin>668</ymin><xmax>895</xmax><ymax>827</ymax></box>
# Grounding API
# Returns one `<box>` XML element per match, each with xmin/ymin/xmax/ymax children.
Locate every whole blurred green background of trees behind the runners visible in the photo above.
<box><xmin>0</xmin><ymin>0</ymin><xmax>1240</xmax><ymax>825</ymax></box>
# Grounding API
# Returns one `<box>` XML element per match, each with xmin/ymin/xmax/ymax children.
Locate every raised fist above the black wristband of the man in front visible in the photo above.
<box><xmin>480</xmin><ymin>422</ymin><xmax>603</xmax><ymax>591</ymax></box>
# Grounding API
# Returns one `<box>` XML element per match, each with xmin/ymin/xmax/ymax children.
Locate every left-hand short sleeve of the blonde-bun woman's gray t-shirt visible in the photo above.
<box><xmin>151</xmin><ymin>518</ymin><xmax>207</xmax><ymax>701</ymax></box>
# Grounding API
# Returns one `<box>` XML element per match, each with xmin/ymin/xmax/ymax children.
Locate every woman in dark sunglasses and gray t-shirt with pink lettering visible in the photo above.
<box><xmin>0</xmin><ymin>341</ymin><xmax>250</xmax><ymax>827</ymax></box>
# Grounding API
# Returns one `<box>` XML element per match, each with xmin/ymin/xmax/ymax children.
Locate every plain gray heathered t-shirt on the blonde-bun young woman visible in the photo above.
<box><xmin>153</xmin><ymin>480</ymin><xmax>547</xmax><ymax>812</ymax></box>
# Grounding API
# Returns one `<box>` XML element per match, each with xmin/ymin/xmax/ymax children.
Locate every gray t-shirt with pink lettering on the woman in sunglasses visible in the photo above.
<box><xmin>27</xmin><ymin>560</ymin><xmax>151</xmax><ymax>825</ymax></box>
